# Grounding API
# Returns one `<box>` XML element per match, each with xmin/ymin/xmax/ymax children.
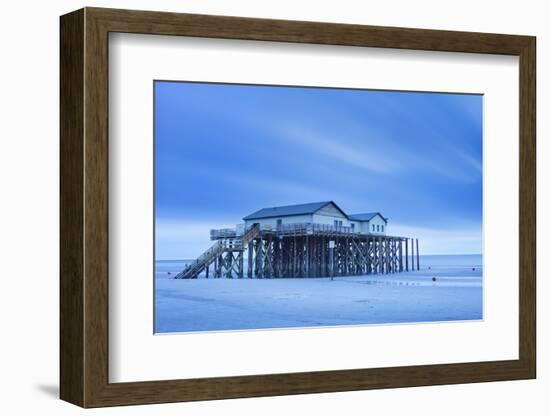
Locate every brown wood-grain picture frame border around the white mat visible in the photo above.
<box><xmin>60</xmin><ymin>8</ymin><xmax>536</xmax><ymax>407</ymax></box>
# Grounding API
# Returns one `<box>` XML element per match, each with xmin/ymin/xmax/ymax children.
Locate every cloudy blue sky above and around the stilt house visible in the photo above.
<box><xmin>155</xmin><ymin>81</ymin><xmax>483</xmax><ymax>259</ymax></box>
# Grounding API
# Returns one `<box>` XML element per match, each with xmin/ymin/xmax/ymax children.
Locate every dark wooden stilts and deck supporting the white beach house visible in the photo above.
<box><xmin>196</xmin><ymin>227</ymin><xmax>420</xmax><ymax>278</ymax></box>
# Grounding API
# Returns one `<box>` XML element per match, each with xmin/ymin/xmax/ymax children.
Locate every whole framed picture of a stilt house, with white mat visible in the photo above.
<box><xmin>60</xmin><ymin>8</ymin><xmax>536</xmax><ymax>407</ymax></box>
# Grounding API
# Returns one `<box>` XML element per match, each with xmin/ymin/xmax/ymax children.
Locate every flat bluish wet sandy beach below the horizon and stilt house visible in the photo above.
<box><xmin>155</xmin><ymin>256</ymin><xmax>483</xmax><ymax>333</ymax></box>
